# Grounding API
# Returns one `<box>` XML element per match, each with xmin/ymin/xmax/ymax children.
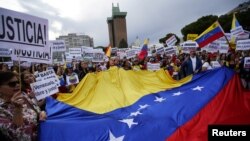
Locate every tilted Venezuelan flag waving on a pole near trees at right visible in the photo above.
<box><xmin>195</xmin><ymin>21</ymin><xmax>224</xmax><ymax>48</ymax></box>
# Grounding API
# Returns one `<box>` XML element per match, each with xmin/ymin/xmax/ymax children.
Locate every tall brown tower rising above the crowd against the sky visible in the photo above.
<box><xmin>107</xmin><ymin>4</ymin><xmax>128</xmax><ymax>48</ymax></box>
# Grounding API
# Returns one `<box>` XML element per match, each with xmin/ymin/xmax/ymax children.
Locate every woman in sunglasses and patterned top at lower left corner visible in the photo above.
<box><xmin>0</xmin><ymin>72</ymin><xmax>45</xmax><ymax>141</ymax></box>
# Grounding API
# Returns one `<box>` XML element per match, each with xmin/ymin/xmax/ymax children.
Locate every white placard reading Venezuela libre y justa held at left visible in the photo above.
<box><xmin>30</xmin><ymin>78</ymin><xmax>59</xmax><ymax>100</ymax></box>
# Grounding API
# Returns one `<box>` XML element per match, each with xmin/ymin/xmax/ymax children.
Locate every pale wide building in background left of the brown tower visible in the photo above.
<box><xmin>56</xmin><ymin>33</ymin><xmax>94</xmax><ymax>49</ymax></box>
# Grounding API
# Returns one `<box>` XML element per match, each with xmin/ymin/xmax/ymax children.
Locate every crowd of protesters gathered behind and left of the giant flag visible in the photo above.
<box><xmin>0</xmin><ymin>47</ymin><xmax>250</xmax><ymax>140</ymax></box>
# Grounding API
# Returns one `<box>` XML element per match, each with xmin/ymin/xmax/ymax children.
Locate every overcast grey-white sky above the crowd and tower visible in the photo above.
<box><xmin>0</xmin><ymin>0</ymin><xmax>248</xmax><ymax>46</ymax></box>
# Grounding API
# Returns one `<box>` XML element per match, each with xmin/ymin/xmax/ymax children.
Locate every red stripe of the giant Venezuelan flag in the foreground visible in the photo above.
<box><xmin>167</xmin><ymin>75</ymin><xmax>250</xmax><ymax>141</ymax></box>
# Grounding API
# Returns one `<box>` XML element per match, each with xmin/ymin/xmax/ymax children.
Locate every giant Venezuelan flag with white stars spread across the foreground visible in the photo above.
<box><xmin>39</xmin><ymin>67</ymin><xmax>250</xmax><ymax>141</ymax></box>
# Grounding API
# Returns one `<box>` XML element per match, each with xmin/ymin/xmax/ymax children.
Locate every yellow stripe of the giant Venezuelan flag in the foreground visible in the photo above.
<box><xmin>57</xmin><ymin>67</ymin><xmax>192</xmax><ymax>114</ymax></box>
